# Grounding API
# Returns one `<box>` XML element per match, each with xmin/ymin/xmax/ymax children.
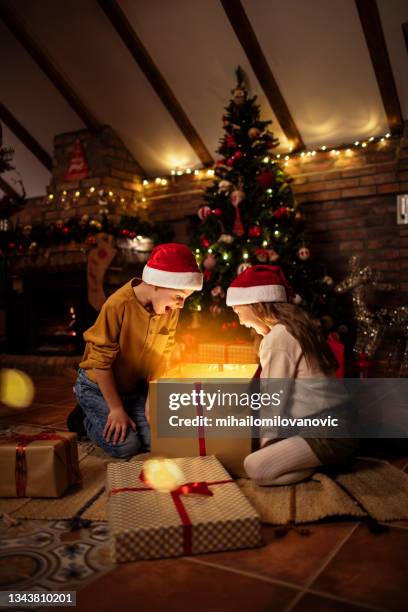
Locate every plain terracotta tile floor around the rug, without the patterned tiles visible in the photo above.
<box><xmin>0</xmin><ymin>374</ymin><xmax>408</xmax><ymax>612</ymax></box>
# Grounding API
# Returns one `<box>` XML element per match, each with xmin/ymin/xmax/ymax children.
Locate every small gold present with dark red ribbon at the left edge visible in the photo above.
<box><xmin>0</xmin><ymin>431</ymin><xmax>81</xmax><ymax>497</ymax></box>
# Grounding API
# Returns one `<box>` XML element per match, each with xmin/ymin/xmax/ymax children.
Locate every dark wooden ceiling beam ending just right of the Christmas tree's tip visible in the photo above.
<box><xmin>220</xmin><ymin>0</ymin><xmax>305</xmax><ymax>151</ymax></box>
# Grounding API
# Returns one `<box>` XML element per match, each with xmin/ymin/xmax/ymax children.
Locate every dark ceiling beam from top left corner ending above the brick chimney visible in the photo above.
<box><xmin>0</xmin><ymin>2</ymin><xmax>100</xmax><ymax>131</ymax></box>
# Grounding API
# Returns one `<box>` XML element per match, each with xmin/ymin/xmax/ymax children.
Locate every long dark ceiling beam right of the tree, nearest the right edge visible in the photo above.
<box><xmin>355</xmin><ymin>0</ymin><xmax>404</xmax><ymax>134</ymax></box>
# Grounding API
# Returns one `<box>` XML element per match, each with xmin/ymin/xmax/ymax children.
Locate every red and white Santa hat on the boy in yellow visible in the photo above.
<box><xmin>142</xmin><ymin>242</ymin><xmax>203</xmax><ymax>291</ymax></box>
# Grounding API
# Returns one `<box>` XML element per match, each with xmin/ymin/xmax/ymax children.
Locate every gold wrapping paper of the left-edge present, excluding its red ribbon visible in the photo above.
<box><xmin>0</xmin><ymin>431</ymin><xmax>80</xmax><ymax>497</ymax></box>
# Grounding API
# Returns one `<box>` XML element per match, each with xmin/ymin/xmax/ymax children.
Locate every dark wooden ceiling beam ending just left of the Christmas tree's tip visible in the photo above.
<box><xmin>98</xmin><ymin>0</ymin><xmax>214</xmax><ymax>166</ymax></box>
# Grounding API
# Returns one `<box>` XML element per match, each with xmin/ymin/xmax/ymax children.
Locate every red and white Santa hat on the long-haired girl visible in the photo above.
<box><xmin>227</xmin><ymin>265</ymin><xmax>298</xmax><ymax>306</ymax></box>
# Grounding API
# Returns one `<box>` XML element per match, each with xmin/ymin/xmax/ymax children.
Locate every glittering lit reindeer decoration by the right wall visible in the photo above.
<box><xmin>334</xmin><ymin>255</ymin><xmax>408</xmax><ymax>377</ymax></box>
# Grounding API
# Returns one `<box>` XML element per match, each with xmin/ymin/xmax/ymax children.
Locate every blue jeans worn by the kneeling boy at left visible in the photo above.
<box><xmin>73</xmin><ymin>368</ymin><xmax>150</xmax><ymax>459</ymax></box>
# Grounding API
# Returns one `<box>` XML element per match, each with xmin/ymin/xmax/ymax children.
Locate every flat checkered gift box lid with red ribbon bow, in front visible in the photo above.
<box><xmin>107</xmin><ymin>456</ymin><xmax>262</xmax><ymax>562</ymax></box>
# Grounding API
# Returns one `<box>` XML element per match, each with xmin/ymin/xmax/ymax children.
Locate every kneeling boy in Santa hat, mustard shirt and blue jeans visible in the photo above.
<box><xmin>68</xmin><ymin>243</ymin><xmax>203</xmax><ymax>458</ymax></box>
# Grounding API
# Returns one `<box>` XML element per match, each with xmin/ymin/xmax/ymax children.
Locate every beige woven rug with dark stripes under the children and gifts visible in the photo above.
<box><xmin>0</xmin><ymin>443</ymin><xmax>408</xmax><ymax>525</ymax></box>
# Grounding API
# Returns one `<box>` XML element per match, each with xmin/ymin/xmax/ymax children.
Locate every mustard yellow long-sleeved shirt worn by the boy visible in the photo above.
<box><xmin>79</xmin><ymin>278</ymin><xmax>179</xmax><ymax>393</ymax></box>
